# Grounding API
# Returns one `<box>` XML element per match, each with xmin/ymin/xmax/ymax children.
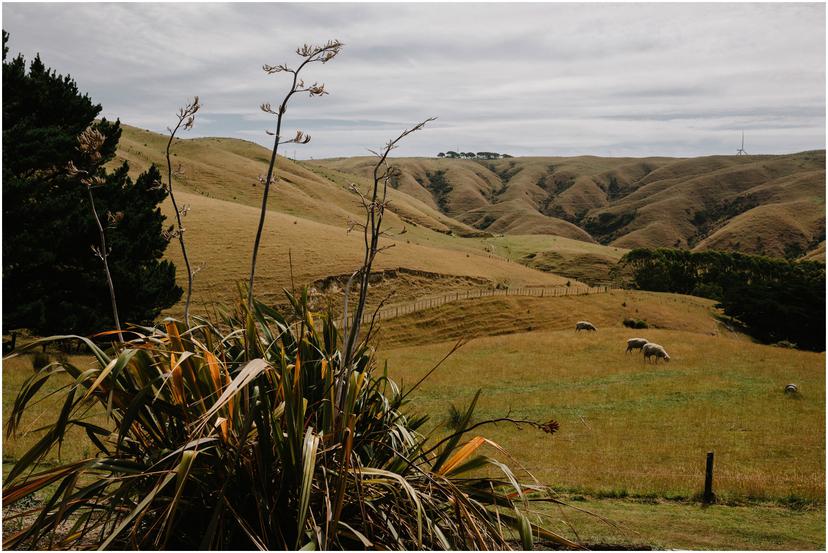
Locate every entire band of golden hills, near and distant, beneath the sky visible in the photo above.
<box><xmin>112</xmin><ymin>125</ymin><xmax>825</xmax><ymax>313</ymax></box>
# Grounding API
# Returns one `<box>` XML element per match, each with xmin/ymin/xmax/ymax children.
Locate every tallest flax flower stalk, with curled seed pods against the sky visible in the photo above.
<box><xmin>247</xmin><ymin>40</ymin><xmax>343</xmax><ymax>310</ymax></box>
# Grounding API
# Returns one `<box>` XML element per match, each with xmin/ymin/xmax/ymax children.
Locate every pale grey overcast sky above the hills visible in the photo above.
<box><xmin>2</xmin><ymin>2</ymin><xmax>826</xmax><ymax>159</ymax></box>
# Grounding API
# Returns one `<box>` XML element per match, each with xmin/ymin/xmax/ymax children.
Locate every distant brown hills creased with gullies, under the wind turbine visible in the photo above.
<box><xmin>319</xmin><ymin>151</ymin><xmax>825</xmax><ymax>258</ymax></box>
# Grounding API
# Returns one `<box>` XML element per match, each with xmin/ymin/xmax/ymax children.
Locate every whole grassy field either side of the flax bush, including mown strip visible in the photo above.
<box><xmin>3</xmin><ymin>291</ymin><xmax>825</xmax><ymax>550</ymax></box>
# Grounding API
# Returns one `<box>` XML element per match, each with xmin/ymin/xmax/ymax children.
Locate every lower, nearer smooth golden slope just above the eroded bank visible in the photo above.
<box><xmin>154</xmin><ymin>188</ymin><xmax>568</xmax><ymax>314</ymax></box>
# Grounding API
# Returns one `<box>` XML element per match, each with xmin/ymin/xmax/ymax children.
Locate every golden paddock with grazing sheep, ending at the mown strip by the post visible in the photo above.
<box><xmin>380</xmin><ymin>292</ymin><xmax>825</xmax><ymax>505</ymax></box>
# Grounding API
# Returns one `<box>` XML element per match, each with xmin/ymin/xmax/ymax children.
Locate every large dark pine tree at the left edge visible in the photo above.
<box><xmin>3</xmin><ymin>32</ymin><xmax>182</xmax><ymax>334</ymax></box>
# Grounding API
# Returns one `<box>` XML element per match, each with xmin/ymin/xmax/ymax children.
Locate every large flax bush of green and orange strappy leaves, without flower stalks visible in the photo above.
<box><xmin>3</xmin><ymin>292</ymin><xmax>574</xmax><ymax>549</ymax></box>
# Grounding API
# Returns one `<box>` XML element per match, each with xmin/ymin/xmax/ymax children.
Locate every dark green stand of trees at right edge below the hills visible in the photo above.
<box><xmin>619</xmin><ymin>248</ymin><xmax>825</xmax><ymax>351</ymax></box>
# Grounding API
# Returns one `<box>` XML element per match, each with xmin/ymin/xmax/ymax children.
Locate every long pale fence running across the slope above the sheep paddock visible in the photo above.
<box><xmin>362</xmin><ymin>286</ymin><xmax>617</xmax><ymax>324</ymax></box>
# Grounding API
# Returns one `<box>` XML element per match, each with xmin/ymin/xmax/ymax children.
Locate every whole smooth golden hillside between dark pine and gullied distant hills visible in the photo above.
<box><xmin>114</xmin><ymin>122</ymin><xmax>632</xmax><ymax>314</ymax></box>
